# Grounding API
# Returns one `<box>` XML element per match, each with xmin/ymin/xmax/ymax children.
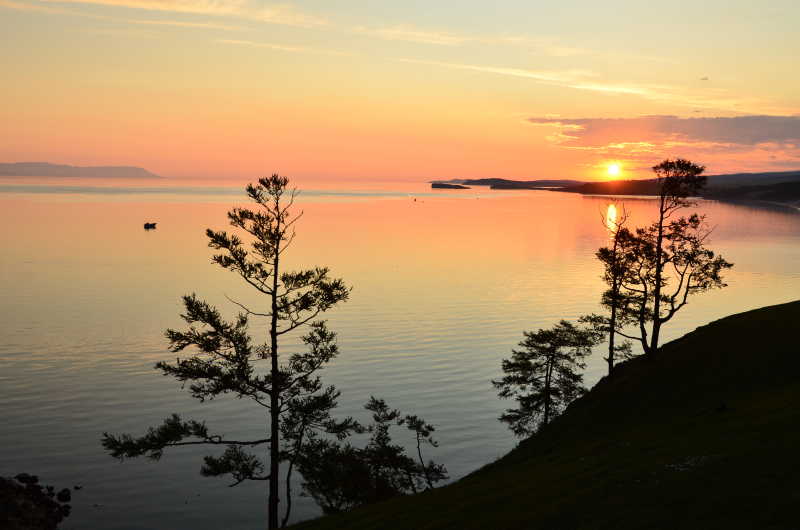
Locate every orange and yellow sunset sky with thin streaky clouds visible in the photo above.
<box><xmin>0</xmin><ymin>0</ymin><xmax>800</xmax><ymax>181</ymax></box>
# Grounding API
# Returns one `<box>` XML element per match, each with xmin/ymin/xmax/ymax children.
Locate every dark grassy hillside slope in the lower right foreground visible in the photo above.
<box><xmin>299</xmin><ymin>302</ymin><xmax>800</xmax><ymax>530</ymax></box>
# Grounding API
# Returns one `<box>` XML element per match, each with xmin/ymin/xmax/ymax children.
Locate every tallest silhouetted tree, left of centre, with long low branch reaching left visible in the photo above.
<box><xmin>103</xmin><ymin>175</ymin><xmax>356</xmax><ymax>530</ymax></box>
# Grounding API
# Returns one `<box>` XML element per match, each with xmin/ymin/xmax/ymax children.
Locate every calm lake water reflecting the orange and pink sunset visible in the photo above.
<box><xmin>0</xmin><ymin>179</ymin><xmax>800</xmax><ymax>529</ymax></box>
